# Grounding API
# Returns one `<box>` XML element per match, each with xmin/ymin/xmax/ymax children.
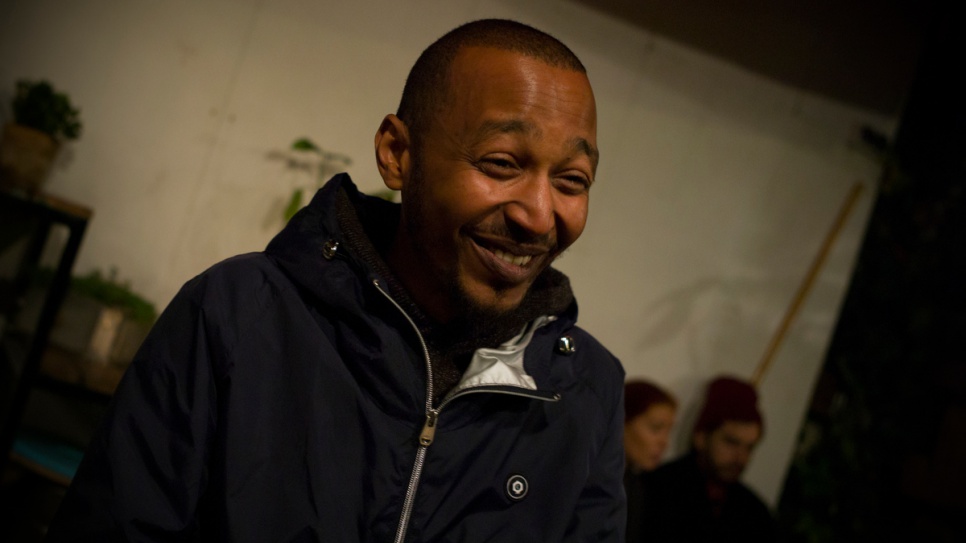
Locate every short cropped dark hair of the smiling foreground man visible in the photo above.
<box><xmin>396</xmin><ymin>19</ymin><xmax>587</xmax><ymax>150</ymax></box>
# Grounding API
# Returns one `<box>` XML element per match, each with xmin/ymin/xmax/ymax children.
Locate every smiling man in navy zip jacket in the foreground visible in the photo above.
<box><xmin>49</xmin><ymin>20</ymin><xmax>625</xmax><ymax>542</ymax></box>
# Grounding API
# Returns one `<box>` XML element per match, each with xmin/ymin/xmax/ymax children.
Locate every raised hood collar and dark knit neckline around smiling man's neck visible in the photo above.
<box><xmin>266</xmin><ymin>173</ymin><xmax>577</xmax><ymax>392</ymax></box>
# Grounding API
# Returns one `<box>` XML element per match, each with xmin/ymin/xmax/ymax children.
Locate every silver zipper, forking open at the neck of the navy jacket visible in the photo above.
<box><xmin>372</xmin><ymin>279</ymin><xmax>560</xmax><ymax>543</ymax></box>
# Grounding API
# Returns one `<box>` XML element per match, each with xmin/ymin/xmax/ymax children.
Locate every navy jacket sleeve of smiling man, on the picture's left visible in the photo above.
<box><xmin>46</xmin><ymin>281</ymin><xmax>217</xmax><ymax>543</ymax></box>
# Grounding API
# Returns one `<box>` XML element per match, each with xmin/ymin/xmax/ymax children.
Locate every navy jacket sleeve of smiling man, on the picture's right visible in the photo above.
<box><xmin>566</xmin><ymin>372</ymin><xmax>627</xmax><ymax>542</ymax></box>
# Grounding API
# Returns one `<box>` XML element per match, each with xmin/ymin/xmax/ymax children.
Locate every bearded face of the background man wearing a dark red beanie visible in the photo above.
<box><xmin>694</xmin><ymin>421</ymin><xmax>761</xmax><ymax>483</ymax></box>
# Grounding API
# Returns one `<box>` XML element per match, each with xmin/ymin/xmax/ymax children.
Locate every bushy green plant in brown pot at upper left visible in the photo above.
<box><xmin>0</xmin><ymin>79</ymin><xmax>82</xmax><ymax>194</ymax></box>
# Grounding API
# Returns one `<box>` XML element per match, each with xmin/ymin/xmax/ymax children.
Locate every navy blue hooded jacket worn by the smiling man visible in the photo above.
<box><xmin>48</xmin><ymin>175</ymin><xmax>625</xmax><ymax>543</ymax></box>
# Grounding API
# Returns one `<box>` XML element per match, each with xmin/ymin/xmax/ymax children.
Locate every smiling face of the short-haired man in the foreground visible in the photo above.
<box><xmin>391</xmin><ymin>47</ymin><xmax>597</xmax><ymax>321</ymax></box>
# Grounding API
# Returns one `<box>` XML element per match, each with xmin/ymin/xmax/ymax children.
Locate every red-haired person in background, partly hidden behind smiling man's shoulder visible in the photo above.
<box><xmin>624</xmin><ymin>379</ymin><xmax>677</xmax><ymax>543</ymax></box>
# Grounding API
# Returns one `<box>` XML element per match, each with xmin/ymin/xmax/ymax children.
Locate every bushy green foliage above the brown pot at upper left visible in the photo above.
<box><xmin>12</xmin><ymin>79</ymin><xmax>83</xmax><ymax>141</ymax></box>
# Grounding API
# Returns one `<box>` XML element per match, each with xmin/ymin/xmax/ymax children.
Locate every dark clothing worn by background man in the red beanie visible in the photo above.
<box><xmin>644</xmin><ymin>453</ymin><xmax>777</xmax><ymax>543</ymax></box>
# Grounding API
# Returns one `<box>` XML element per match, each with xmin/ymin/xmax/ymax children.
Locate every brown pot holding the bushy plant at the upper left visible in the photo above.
<box><xmin>0</xmin><ymin>123</ymin><xmax>60</xmax><ymax>195</ymax></box>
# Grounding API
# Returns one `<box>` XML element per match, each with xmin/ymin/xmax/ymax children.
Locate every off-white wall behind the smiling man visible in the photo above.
<box><xmin>0</xmin><ymin>0</ymin><xmax>895</xmax><ymax>510</ymax></box>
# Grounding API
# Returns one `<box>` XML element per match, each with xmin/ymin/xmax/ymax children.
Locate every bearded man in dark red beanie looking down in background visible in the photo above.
<box><xmin>640</xmin><ymin>377</ymin><xmax>777</xmax><ymax>543</ymax></box>
